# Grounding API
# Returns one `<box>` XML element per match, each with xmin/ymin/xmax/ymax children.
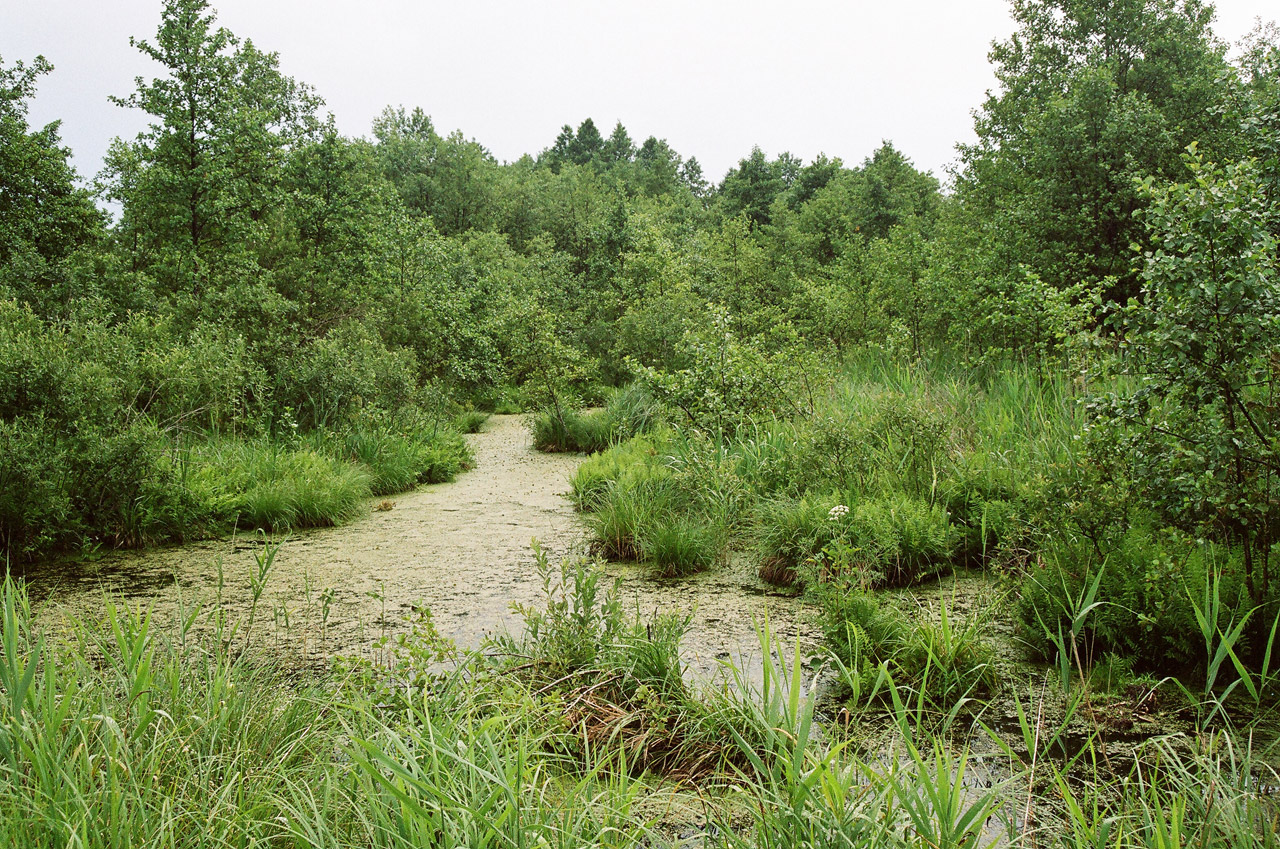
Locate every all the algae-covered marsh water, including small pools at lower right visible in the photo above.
<box><xmin>28</xmin><ymin>416</ymin><xmax>1280</xmax><ymax>839</ymax></box>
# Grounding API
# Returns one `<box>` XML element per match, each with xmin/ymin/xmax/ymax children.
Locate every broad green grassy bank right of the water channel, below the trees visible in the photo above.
<box><xmin>558</xmin><ymin>357</ymin><xmax>1280</xmax><ymax>696</ymax></box>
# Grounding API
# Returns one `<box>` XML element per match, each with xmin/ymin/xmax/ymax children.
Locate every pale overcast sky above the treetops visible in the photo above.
<box><xmin>0</xmin><ymin>0</ymin><xmax>1275</xmax><ymax>188</ymax></box>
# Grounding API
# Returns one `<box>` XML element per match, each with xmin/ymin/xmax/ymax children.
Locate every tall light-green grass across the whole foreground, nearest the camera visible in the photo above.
<box><xmin>0</xmin><ymin>562</ymin><xmax>1277</xmax><ymax>846</ymax></box>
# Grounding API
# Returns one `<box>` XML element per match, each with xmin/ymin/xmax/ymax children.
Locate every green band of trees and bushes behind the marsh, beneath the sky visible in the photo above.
<box><xmin>0</xmin><ymin>0</ymin><xmax>1280</xmax><ymax>571</ymax></box>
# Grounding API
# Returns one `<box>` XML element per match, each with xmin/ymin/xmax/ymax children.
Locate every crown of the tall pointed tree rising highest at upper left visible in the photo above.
<box><xmin>106</xmin><ymin>0</ymin><xmax>319</xmax><ymax>300</ymax></box>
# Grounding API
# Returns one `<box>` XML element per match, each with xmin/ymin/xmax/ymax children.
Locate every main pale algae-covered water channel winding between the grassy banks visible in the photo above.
<box><xmin>28</xmin><ymin>416</ymin><xmax>809</xmax><ymax>677</ymax></box>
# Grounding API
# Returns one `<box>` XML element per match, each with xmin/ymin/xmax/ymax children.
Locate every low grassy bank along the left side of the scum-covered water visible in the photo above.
<box><xmin>0</xmin><ymin>423</ymin><xmax>472</xmax><ymax>561</ymax></box>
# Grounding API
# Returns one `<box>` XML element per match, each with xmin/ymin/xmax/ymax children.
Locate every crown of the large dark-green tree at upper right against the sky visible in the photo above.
<box><xmin>957</xmin><ymin>0</ymin><xmax>1238</xmax><ymax>302</ymax></box>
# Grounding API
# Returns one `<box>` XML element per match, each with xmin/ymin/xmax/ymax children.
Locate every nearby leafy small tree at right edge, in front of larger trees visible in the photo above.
<box><xmin>1093</xmin><ymin>149</ymin><xmax>1280</xmax><ymax>603</ymax></box>
